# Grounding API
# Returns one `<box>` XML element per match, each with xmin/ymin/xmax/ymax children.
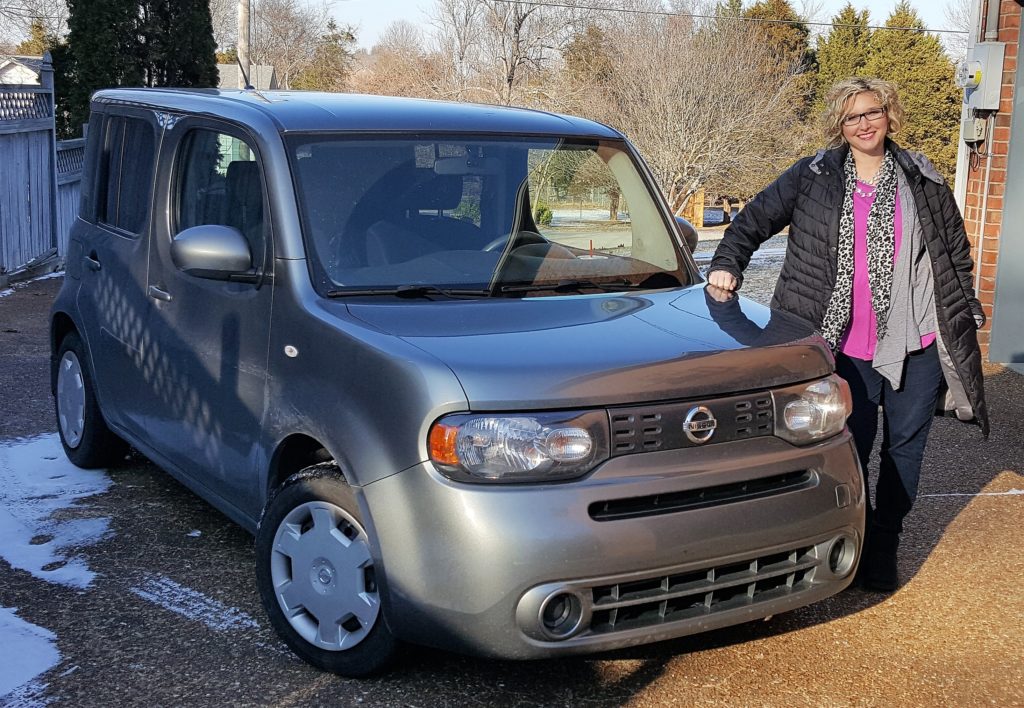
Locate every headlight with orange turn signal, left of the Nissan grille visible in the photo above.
<box><xmin>428</xmin><ymin>411</ymin><xmax>608</xmax><ymax>483</ymax></box>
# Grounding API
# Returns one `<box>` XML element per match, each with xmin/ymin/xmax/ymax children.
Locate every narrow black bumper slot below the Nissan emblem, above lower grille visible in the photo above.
<box><xmin>588</xmin><ymin>470</ymin><xmax>817</xmax><ymax>522</ymax></box>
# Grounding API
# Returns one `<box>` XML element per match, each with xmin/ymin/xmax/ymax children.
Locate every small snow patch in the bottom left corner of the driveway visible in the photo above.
<box><xmin>0</xmin><ymin>608</ymin><xmax>60</xmax><ymax>708</ymax></box>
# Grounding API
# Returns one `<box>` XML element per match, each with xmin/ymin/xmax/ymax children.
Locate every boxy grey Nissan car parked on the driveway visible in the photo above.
<box><xmin>51</xmin><ymin>89</ymin><xmax>865</xmax><ymax>676</ymax></box>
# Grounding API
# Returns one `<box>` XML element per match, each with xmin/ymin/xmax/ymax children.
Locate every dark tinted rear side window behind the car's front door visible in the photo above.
<box><xmin>96</xmin><ymin>116</ymin><xmax>156</xmax><ymax>234</ymax></box>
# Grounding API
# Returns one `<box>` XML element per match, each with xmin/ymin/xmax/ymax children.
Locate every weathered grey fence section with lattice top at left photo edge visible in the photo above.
<box><xmin>0</xmin><ymin>54</ymin><xmax>59</xmax><ymax>286</ymax></box>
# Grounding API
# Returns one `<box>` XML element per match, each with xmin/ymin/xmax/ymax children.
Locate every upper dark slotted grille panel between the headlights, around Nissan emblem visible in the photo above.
<box><xmin>608</xmin><ymin>391</ymin><xmax>775</xmax><ymax>456</ymax></box>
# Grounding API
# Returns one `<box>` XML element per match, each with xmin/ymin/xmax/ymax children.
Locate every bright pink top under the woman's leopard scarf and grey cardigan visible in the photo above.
<box><xmin>839</xmin><ymin>179</ymin><xmax>935</xmax><ymax>362</ymax></box>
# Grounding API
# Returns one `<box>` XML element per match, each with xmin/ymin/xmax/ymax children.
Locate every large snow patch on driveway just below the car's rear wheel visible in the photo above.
<box><xmin>0</xmin><ymin>433</ymin><xmax>111</xmax><ymax>588</ymax></box>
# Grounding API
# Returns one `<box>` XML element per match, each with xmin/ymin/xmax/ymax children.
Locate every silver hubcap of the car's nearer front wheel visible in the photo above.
<box><xmin>270</xmin><ymin>501</ymin><xmax>380</xmax><ymax>652</ymax></box>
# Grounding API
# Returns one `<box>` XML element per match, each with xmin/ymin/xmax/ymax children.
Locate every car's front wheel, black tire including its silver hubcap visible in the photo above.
<box><xmin>256</xmin><ymin>462</ymin><xmax>398</xmax><ymax>677</ymax></box>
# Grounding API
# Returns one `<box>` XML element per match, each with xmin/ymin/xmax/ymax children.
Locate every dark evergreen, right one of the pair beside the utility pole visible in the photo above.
<box><xmin>138</xmin><ymin>0</ymin><xmax>218</xmax><ymax>88</ymax></box>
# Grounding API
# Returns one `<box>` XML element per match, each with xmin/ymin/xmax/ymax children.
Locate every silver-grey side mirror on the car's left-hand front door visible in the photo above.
<box><xmin>171</xmin><ymin>224</ymin><xmax>253</xmax><ymax>281</ymax></box>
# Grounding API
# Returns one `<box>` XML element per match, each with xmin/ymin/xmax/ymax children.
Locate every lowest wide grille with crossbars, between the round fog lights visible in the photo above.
<box><xmin>590</xmin><ymin>546</ymin><xmax>818</xmax><ymax>634</ymax></box>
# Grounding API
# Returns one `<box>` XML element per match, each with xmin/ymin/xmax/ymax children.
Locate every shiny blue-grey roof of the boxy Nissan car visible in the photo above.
<box><xmin>92</xmin><ymin>88</ymin><xmax>622</xmax><ymax>138</ymax></box>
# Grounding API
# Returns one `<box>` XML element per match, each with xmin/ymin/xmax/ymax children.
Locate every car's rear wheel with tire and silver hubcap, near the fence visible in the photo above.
<box><xmin>53</xmin><ymin>332</ymin><xmax>128</xmax><ymax>468</ymax></box>
